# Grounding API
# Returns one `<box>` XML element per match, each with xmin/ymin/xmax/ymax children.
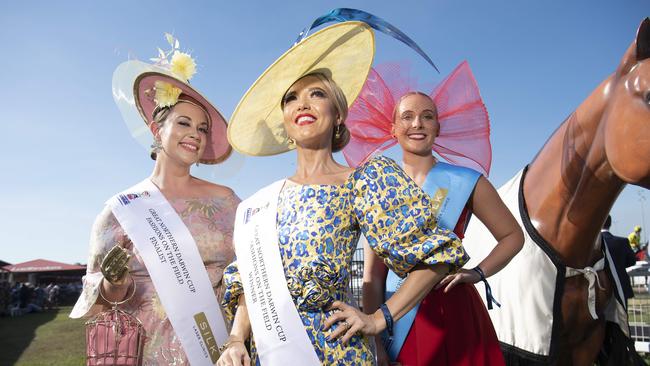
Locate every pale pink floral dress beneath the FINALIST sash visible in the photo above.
<box><xmin>70</xmin><ymin>194</ymin><xmax>240</xmax><ymax>365</ymax></box>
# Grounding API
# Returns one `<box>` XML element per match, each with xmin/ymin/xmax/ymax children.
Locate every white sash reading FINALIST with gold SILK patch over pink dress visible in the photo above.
<box><xmin>106</xmin><ymin>179</ymin><xmax>228</xmax><ymax>366</ymax></box>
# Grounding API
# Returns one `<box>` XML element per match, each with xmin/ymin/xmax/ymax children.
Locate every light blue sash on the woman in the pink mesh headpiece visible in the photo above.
<box><xmin>385</xmin><ymin>162</ymin><xmax>481</xmax><ymax>361</ymax></box>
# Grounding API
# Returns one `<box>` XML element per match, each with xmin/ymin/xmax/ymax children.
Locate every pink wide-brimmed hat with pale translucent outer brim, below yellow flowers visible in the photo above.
<box><xmin>113</xmin><ymin>61</ymin><xmax>232</xmax><ymax>164</ymax></box>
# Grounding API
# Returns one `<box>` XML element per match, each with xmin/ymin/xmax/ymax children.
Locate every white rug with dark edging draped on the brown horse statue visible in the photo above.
<box><xmin>463</xmin><ymin>170</ymin><xmax>629</xmax><ymax>363</ymax></box>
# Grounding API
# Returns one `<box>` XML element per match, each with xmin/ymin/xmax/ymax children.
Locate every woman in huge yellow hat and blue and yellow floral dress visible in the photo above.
<box><xmin>218</xmin><ymin>22</ymin><xmax>468</xmax><ymax>365</ymax></box>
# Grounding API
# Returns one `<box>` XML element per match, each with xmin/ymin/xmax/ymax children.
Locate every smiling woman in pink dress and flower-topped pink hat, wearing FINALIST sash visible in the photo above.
<box><xmin>70</xmin><ymin>35</ymin><xmax>240</xmax><ymax>365</ymax></box>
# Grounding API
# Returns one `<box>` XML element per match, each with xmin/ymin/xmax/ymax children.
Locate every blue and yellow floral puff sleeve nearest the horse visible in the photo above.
<box><xmin>350</xmin><ymin>156</ymin><xmax>469</xmax><ymax>277</ymax></box>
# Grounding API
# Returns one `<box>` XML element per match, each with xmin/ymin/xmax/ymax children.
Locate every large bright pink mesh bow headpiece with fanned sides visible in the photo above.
<box><xmin>343</xmin><ymin>61</ymin><xmax>492</xmax><ymax>176</ymax></box>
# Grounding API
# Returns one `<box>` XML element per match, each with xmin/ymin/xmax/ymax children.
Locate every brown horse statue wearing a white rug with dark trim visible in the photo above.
<box><xmin>464</xmin><ymin>18</ymin><xmax>650</xmax><ymax>365</ymax></box>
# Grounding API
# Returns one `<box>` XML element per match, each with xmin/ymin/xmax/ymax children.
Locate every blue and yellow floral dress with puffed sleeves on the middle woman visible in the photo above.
<box><xmin>222</xmin><ymin>156</ymin><xmax>468</xmax><ymax>365</ymax></box>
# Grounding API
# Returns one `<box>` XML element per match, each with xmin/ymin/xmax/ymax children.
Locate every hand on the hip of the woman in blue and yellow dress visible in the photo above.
<box><xmin>323</xmin><ymin>301</ymin><xmax>380</xmax><ymax>344</ymax></box>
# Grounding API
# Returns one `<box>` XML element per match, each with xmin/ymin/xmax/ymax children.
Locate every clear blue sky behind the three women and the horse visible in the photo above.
<box><xmin>0</xmin><ymin>0</ymin><xmax>650</xmax><ymax>263</ymax></box>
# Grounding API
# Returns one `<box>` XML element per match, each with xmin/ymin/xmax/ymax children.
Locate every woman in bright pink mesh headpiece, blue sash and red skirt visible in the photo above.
<box><xmin>344</xmin><ymin>62</ymin><xmax>523</xmax><ymax>366</ymax></box>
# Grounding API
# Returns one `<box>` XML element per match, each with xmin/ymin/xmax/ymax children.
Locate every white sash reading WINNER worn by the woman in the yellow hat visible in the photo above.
<box><xmin>234</xmin><ymin>180</ymin><xmax>321</xmax><ymax>366</ymax></box>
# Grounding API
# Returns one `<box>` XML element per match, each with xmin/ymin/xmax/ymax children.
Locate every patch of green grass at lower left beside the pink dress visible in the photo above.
<box><xmin>0</xmin><ymin>307</ymin><xmax>86</xmax><ymax>366</ymax></box>
